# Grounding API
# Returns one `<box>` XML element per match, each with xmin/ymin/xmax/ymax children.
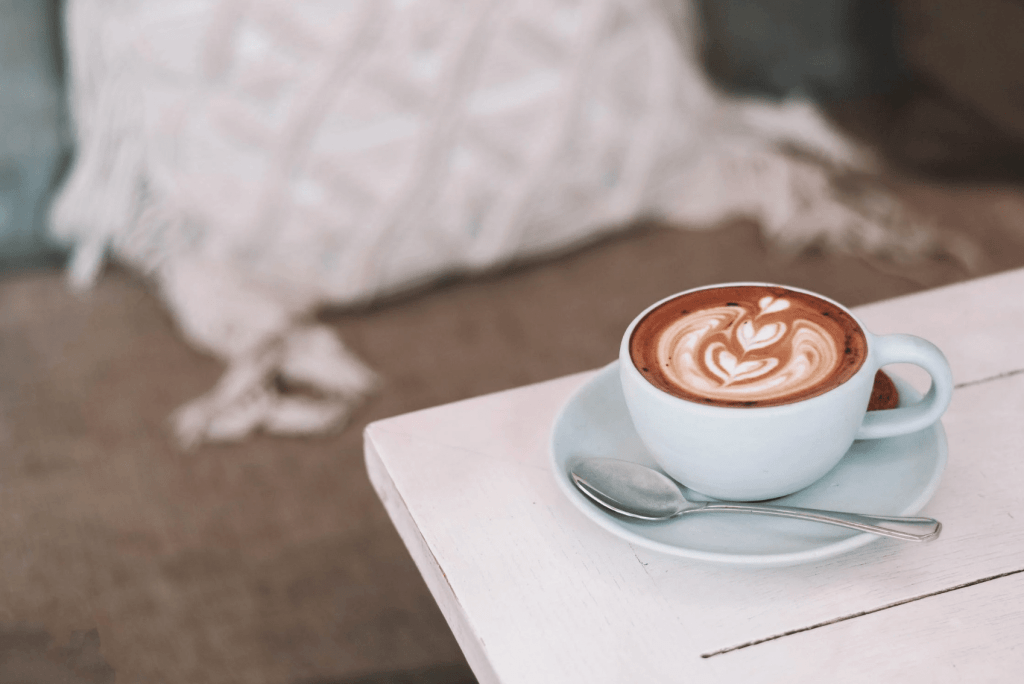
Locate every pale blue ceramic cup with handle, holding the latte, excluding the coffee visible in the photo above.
<box><xmin>618</xmin><ymin>283</ymin><xmax>953</xmax><ymax>501</ymax></box>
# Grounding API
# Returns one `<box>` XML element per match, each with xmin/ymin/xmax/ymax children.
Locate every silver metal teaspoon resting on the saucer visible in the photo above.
<box><xmin>570</xmin><ymin>459</ymin><xmax>942</xmax><ymax>542</ymax></box>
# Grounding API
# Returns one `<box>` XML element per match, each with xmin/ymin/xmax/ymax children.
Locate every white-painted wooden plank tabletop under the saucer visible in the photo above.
<box><xmin>365</xmin><ymin>269</ymin><xmax>1024</xmax><ymax>684</ymax></box>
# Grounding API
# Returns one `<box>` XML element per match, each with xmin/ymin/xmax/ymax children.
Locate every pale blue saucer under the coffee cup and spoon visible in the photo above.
<box><xmin>551</xmin><ymin>361</ymin><xmax>946</xmax><ymax>566</ymax></box>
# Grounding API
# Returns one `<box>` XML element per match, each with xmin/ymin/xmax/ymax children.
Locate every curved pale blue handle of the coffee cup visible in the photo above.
<box><xmin>856</xmin><ymin>335</ymin><xmax>953</xmax><ymax>439</ymax></box>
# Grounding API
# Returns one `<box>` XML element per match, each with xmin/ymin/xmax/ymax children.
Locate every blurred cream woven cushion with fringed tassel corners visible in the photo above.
<box><xmin>51</xmin><ymin>0</ymin><xmax>937</xmax><ymax>444</ymax></box>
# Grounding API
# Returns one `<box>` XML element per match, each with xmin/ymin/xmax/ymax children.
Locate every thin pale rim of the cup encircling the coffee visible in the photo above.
<box><xmin>618</xmin><ymin>281</ymin><xmax>874</xmax><ymax>413</ymax></box>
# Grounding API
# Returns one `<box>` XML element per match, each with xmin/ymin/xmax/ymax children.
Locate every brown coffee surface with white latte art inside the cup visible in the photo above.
<box><xmin>630</xmin><ymin>286</ymin><xmax>867</xmax><ymax>408</ymax></box>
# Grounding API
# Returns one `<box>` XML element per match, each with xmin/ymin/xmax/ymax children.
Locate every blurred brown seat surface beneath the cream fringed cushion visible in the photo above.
<box><xmin>6</xmin><ymin>181</ymin><xmax>1024</xmax><ymax>684</ymax></box>
